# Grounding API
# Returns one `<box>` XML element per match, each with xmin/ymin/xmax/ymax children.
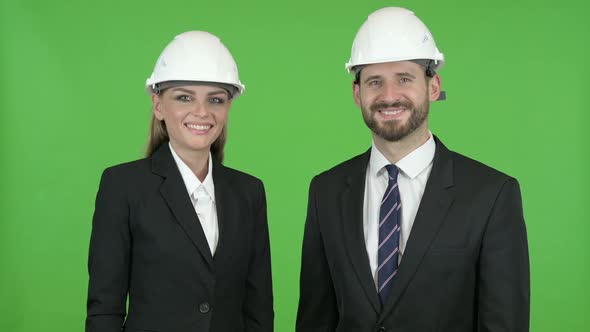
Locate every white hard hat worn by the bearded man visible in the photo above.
<box><xmin>346</xmin><ymin>7</ymin><xmax>444</xmax><ymax>73</ymax></box>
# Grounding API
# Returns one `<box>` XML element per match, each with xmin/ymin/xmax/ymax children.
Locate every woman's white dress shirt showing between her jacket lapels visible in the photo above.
<box><xmin>168</xmin><ymin>143</ymin><xmax>219</xmax><ymax>255</ymax></box>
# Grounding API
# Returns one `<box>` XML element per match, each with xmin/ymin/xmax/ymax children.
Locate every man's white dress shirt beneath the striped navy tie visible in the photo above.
<box><xmin>363</xmin><ymin>134</ymin><xmax>436</xmax><ymax>287</ymax></box>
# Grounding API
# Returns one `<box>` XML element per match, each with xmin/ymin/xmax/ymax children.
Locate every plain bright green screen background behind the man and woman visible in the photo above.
<box><xmin>0</xmin><ymin>0</ymin><xmax>590</xmax><ymax>332</ymax></box>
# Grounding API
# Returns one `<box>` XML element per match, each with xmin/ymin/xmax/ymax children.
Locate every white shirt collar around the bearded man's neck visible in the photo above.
<box><xmin>369</xmin><ymin>133</ymin><xmax>436</xmax><ymax>179</ymax></box>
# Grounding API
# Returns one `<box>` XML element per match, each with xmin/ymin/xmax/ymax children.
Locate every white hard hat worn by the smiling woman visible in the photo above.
<box><xmin>145</xmin><ymin>31</ymin><xmax>245</xmax><ymax>98</ymax></box>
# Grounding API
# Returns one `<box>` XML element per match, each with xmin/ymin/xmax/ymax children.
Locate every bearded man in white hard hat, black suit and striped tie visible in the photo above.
<box><xmin>297</xmin><ymin>8</ymin><xmax>530</xmax><ymax>332</ymax></box>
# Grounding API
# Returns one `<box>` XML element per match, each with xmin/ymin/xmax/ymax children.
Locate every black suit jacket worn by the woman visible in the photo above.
<box><xmin>86</xmin><ymin>144</ymin><xmax>274</xmax><ymax>332</ymax></box>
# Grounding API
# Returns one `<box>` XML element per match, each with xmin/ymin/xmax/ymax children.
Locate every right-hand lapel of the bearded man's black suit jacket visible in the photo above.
<box><xmin>381</xmin><ymin>136</ymin><xmax>454</xmax><ymax>318</ymax></box>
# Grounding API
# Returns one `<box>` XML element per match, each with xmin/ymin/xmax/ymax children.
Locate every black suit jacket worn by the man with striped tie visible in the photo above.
<box><xmin>297</xmin><ymin>138</ymin><xmax>529</xmax><ymax>332</ymax></box>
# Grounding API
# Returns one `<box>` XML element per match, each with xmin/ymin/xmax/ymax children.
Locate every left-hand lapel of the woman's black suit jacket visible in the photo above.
<box><xmin>152</xmin><ymin>143</ymin><xmax>213</xmax><ymax>269</ymax></box>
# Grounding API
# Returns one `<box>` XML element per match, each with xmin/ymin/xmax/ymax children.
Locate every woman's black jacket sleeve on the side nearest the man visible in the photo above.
<box><xmin>243</xmin><ymin>181</ymin><xmax>274</xmax><ymax>332</ymax></box>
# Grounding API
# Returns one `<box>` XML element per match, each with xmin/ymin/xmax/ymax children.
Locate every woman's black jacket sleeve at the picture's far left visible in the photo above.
<box><xmin>86</xmin><ymin>169</ymin><xmax>131</xmax><ymax>332</ymax></box>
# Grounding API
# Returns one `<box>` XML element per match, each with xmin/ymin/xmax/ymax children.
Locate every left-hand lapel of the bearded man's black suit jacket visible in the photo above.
<box><xmin>341</xmin><ymin>150</ymin><xmax>381</xmax><ymax>313</ymax></box>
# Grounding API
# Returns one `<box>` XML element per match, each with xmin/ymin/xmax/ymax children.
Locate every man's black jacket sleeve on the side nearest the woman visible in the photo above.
<box><xmin>296</xmin><ymin>177</ymin><xmax>339</xmax><ymax>332</ymax></box>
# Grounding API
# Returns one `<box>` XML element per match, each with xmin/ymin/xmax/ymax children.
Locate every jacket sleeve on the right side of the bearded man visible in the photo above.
<box><xmin>477</xmin><ymin>178</ymin><xmax>530</xmax><ymax>332</ymax></box>
